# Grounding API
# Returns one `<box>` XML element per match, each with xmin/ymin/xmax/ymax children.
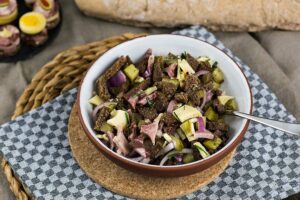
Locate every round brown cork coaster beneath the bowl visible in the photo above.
<box><xmin>68</xmin><ymin>104</ymin><xmax>235</xmax><ymax>199</ymax></box>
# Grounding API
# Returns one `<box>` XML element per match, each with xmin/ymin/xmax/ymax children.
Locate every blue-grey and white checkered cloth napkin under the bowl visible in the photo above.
<box><xmin>0</xmin><ymin>26</ymin><xmax>300</xmax><ymax>199</ymax></box>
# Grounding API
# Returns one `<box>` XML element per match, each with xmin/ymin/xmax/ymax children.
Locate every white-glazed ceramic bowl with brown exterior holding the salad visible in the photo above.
<box><xmin>77</xmin><ymin>34</ymin><xmax>252</xmax><ymax>176</ymax></box>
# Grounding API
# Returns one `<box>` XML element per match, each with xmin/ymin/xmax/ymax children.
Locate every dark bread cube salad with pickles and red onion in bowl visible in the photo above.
<box><xmin>89</xmin><ymin>49</ymin><xmax>237</xmax><ymax>166</ymax></box>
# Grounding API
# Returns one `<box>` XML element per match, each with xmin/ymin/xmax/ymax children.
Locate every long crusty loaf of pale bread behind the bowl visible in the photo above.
<box><xmin>75</xmin><ymin>0</ymin><xmax>300</xmax><ymax>31</ymax></box>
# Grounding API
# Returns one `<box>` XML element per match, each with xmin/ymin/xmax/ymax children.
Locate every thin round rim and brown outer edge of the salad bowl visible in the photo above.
<box><xmin>76</xmin><ymin>34</ymin><xmax>253</xmax><ymax>172</ymax></box>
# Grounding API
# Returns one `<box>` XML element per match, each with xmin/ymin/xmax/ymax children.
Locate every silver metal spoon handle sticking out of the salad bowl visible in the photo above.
<box><xmin>232</xmin><ymin>111</ymin><xmax>300</xmax><ymax>136</ymax></box>
